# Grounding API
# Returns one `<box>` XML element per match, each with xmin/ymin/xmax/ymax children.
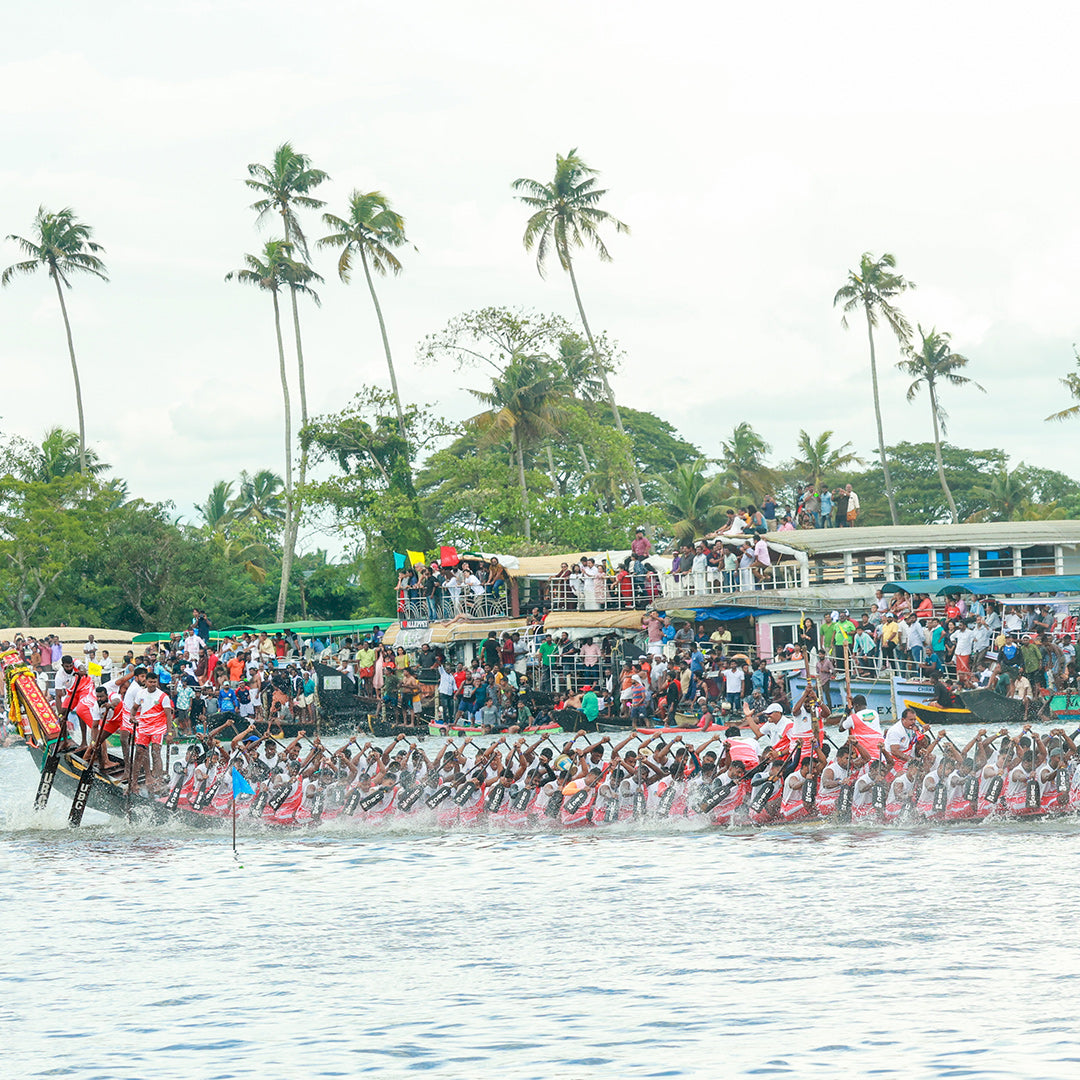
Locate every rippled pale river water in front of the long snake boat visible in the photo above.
<box><xmin>0</xmin><ymin>750</ymin><xmax>1080</xmax><ymax>1080</ymax></box>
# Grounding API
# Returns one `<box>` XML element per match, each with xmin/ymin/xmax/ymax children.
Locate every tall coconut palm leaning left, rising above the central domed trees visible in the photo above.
<box><xmin>511</xmin><ymin>149</ymin><xmax>645</xmax><ymax>507</ymax></box>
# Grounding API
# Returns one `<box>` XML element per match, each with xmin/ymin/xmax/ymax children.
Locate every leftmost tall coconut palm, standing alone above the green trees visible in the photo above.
<box><xmin>0</xmin><ymin>206</ymin><xmax>109</xmax><ymax>474</ymax></box>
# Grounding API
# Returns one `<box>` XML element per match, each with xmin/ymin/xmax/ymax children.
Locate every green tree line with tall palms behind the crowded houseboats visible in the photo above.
<box><xmin>0</xmin><ymin>143</ymin><xmax>1080</xmax><ymax>630</ymax></box>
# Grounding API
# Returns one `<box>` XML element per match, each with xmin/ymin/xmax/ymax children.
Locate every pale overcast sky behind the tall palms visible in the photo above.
<box><xmin>0</xmin><ymin>0</ymin><xmax>1080</xmax><ymax>548</ymax></box>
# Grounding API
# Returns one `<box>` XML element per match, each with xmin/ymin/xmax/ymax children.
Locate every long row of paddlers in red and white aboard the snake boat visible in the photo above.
<box><xmin>130</xmin><ymin>682</ymin><xmax>1080</xmax><ymax>828</ymax></box>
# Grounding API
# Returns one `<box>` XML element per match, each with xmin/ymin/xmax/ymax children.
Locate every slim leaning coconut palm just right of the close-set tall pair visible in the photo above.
<box><xmin>319</xmin><ymin>191</ymin><xmax>408</xmax><ymax>438</ymax></box>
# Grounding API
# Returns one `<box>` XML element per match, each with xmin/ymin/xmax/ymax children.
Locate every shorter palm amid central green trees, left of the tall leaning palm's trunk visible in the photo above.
<box><xmin>469</xmin><ymin>355</ymin><xmax>578</xmax><ymax>540</ymax></box>
